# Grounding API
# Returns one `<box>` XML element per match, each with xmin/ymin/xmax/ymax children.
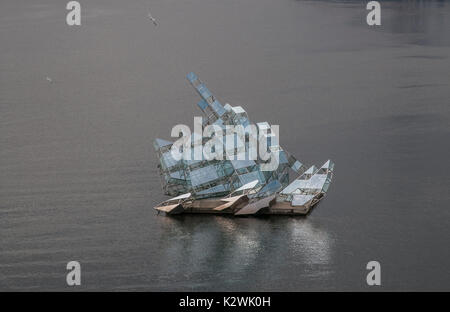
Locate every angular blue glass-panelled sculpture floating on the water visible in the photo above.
<box><xmin>154</xmin><ymin>73</ymin><xmax>334</xmax><ymax>215</ymax></box>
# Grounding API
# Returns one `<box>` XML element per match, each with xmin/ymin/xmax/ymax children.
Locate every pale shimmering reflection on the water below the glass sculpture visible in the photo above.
<box><xmin>158</xmin><ymin>216</ymin><xmax>333</xmax><ymax>278</ymax></box>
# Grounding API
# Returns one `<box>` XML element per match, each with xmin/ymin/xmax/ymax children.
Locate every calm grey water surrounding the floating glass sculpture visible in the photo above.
<box><xmin>0</xmin><ymin>0</ymin><xmax>450</xmax><ymax>291</ymax></box>
